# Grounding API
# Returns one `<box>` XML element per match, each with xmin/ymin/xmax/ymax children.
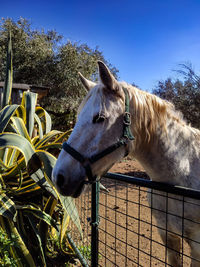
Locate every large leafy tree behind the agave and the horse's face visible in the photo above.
<box><xmin>0</xmin><ymin>18</ymin><xmax>118</xmax><ymax>130</ymax></box>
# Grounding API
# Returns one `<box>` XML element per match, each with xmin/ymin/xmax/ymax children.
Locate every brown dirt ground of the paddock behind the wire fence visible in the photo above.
<box><xmin>70</xmin><ymin>158</ymin><xmax>190</xmax><ymax>267</ymax></box>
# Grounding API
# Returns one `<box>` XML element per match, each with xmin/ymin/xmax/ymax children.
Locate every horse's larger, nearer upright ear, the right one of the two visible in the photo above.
<box><xmin>98</xmin><ymin>61</ymin><xmax>119</xmax><ymax>90</ymax></box>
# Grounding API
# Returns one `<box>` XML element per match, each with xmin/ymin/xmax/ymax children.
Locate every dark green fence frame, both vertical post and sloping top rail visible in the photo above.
<box><xmin>91</xmin><ymin>173</ymin><xmax>200</xmax><ymax>267</ymax></box>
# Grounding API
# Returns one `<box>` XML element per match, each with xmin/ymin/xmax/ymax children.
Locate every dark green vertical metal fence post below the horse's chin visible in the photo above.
<box><xmin>91</xmin><ymin>181</ymin><xmax>99</xmax><ymax>267</ymax></box>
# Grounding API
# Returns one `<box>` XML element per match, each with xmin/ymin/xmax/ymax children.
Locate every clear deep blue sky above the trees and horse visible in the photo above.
<box><xmin>0</xmin><ymin>0</ymin><xmax>200</xmax><ymax>91</ymax></box>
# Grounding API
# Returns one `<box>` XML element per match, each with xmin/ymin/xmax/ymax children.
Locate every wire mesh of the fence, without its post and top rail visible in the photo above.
<box><xmin>68</xmin><ymin>175</ymin><xmax>200</xmax><ymax>267</ymax></box>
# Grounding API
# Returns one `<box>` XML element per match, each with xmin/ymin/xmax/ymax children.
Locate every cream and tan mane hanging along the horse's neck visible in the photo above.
<box><xmin>121</xmin><ymin>82</ymin><xmax>190</xmax><ymax>143</ymax></box>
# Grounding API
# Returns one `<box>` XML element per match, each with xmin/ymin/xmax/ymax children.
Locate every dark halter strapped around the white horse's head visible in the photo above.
<box><xmin>62</xmin><ymin>88</ymin><xmax>135</xmax><ymax>183</ymax></box>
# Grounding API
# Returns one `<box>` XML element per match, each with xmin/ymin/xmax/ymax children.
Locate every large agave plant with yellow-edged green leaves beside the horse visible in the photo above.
<box><xmin>0</xmin><ymin>31</ymin><xmax>81</xmax><ymax>266</ymax></box>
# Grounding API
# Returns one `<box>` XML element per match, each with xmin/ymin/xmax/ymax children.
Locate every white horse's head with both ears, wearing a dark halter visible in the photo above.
<box><xmin>53</xmin><ymin>62</ymin><xmax>134</xmax><ymax>197</ymax></box>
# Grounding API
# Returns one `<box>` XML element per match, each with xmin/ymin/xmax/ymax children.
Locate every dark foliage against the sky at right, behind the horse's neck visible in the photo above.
<box><xmin>153</xmin><ymin>64</ymin><xmax>200</xmax><ymax>128</ymax></box>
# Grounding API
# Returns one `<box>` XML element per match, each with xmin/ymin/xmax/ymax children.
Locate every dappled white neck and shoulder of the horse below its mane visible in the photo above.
<box><xmin>135</xmin><ymin>116</ymin><xmax>200</xmax><ymax>187</ymax></box>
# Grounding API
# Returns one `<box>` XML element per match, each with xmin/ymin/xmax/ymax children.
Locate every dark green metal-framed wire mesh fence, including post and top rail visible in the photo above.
<box><xmin>68</xmin><ymin>173</ymin><xmax>200</xmax><ymax>267</ymax></box>
